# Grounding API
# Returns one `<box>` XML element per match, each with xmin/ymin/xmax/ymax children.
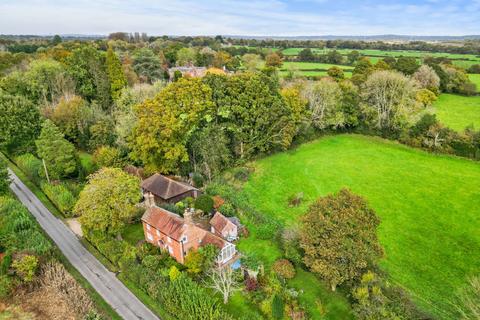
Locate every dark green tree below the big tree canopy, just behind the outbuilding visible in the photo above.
<box><xmin>190</xmin><ymin>124</ymin><xmax>232</xmax><ymax>181</ymax></box>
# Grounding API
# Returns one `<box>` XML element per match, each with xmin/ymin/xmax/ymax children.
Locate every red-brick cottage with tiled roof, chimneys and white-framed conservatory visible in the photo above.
<box><xmin>142</xmin><ymin>195</ymin><xmax>237</xmax><ymax>265</ymax></box>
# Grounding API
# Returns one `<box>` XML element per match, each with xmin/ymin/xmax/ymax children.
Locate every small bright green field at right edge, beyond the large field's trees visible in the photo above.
<box><xmin>433</xmin><ymin>94</ymin><xmax>480</xmax><ymax>131</ymax></box>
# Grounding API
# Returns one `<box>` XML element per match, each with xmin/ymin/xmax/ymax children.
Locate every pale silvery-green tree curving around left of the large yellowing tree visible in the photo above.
<box><xmin>113</xmin><ymin>81</ymin><xmax>165</xmax><ymax>149</ymax></box>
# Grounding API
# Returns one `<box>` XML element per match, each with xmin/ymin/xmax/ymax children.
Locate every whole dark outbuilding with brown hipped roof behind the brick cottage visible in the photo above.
<box><xmin>141</xmin><ymin>173</ymin><xmax>200</xmax><ymax>204</ymax></box>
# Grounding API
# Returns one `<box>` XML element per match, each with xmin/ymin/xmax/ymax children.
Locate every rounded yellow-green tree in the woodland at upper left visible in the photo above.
<box><xmin>24</xmin><ymin>59</ymin><xmax>75</xmax><ymax>105</ymax></box>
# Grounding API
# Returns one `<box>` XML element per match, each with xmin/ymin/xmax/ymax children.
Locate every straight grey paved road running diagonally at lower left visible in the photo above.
<box><xmin>10</xmin><ymin>171</ymin><xmax>159</xmax><ymax>320</ymax></box>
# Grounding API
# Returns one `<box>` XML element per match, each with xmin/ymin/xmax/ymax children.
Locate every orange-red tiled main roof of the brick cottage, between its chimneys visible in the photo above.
<box><xmin>142</xmin><ymin>207</ymin><xmax>184</xmax><ymax>241</ymax></box>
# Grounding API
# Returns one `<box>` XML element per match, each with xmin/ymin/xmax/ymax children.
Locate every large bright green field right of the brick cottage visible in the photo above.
<box><xmin>239</xmin><ymin>135</ymin><xmax>480</xmax><ymax>319</ymax></box>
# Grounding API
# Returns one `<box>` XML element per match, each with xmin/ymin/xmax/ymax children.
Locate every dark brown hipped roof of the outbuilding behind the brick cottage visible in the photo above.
<box><xmin>142</xmin><ymin>173</ymin><xmax>197</xmax><ymax>200</ymax></box>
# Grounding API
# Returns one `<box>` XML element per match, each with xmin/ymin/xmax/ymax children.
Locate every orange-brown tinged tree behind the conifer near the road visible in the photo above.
<box><xmin>42</xmin><ymin>95</ymin><xmax>94</xmax><ymax>148</ymax></box>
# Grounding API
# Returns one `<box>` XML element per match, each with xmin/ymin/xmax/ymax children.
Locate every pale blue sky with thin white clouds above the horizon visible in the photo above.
<box><xmin>0</xmin><ymin>0</ymin><xmax>480</xmax><ymax>36</ymax></box>
